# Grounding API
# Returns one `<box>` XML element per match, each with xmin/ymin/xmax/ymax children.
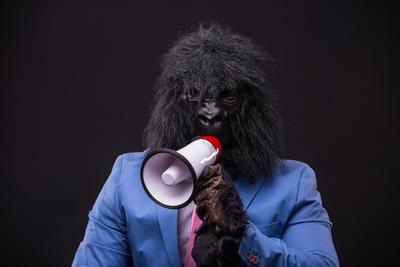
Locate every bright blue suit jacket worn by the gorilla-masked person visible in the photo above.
<box><xmin>72</xmin><ymin>152</ymin><xmax>339</xmax><ymax>267</ymax></box>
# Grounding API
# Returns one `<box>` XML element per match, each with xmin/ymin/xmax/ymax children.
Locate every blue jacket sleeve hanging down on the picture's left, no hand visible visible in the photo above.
<box><xmin>72</xmin><ymin>156</ymin><xmax>132</xmax><ymax>266</ymax></box>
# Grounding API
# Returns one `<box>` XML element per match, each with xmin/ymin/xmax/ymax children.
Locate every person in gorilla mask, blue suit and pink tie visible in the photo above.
<box><xmin>72</xmin><ymin>22</ymin><xmax>339</xmax><ymax>267</ymax></box>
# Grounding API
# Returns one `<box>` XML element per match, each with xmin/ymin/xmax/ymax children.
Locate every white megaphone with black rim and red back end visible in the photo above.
<box><xmin>140</xmin><ymin>136</ymin><xmax>222</xmax><ymax>209</ymax></box>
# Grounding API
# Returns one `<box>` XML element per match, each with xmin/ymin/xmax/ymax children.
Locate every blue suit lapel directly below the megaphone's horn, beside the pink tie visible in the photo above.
<box><xmin>155</xmin><ymin>205</ymin><xmax>181</xmax><ymax>267</ymax></box>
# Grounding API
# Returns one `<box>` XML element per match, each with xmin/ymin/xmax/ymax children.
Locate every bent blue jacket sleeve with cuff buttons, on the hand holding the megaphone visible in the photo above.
<box><xmin>239</xmin><ymin>166</ymin><xmax>339</xmax><ymax>267</ymax></box>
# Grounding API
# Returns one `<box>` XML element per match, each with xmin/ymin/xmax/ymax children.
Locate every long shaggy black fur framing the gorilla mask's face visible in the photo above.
<box><xmin>144</xmin><ymin>23</ymin><xmax>283</xmax><ymax>180</ymax></box>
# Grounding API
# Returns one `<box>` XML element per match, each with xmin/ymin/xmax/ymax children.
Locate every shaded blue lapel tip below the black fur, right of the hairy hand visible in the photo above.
<box><xmin>235</xmin><ymin>176</ymin><xmax>266</xmax><ymax>210</ymax></box>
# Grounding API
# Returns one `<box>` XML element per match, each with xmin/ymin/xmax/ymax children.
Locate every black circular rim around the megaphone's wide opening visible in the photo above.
<box><xmin>140</xmin><ymin>148</ymin><xmax>197</xmax><ymax>209</ymax></box>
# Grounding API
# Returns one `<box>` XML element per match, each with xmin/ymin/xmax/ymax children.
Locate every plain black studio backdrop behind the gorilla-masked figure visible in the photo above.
<box><xmin>0</xmin><ymin>1</ymin><xmax>400</xmax><ymax>266</ymax></box>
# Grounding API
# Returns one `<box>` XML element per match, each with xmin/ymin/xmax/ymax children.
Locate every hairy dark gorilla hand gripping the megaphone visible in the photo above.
<box><xmin>192</xmin><ymin>164</ymin><xmax>247</xmax><ymax>267</ymax></box>
